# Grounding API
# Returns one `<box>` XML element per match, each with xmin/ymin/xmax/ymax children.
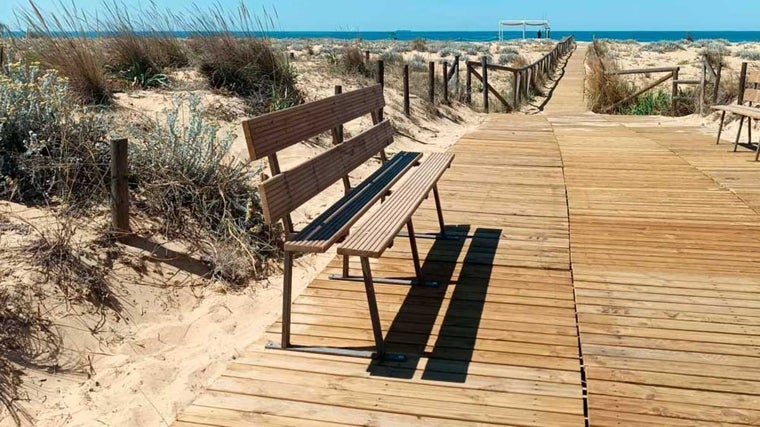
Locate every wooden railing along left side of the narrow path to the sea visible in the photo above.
<box><xmin>466</xmin><ymin>36</ymin><xmax>575</xmax><ymax>112</ymax></box>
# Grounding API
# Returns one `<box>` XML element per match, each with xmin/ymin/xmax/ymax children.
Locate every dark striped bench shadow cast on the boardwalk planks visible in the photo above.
<box><xmin>368</xmin><ymin>225</ymin><xmax>501</xmax><ymax>383</ymax></box>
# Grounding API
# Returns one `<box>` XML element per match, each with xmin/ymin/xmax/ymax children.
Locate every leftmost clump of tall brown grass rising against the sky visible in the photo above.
<box><xmin>21</xmin><ymin>2</ymin><xmax>111</xmax><ymax>104</ymax></box>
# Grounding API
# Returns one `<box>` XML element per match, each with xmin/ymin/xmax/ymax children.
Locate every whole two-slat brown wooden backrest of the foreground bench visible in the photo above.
<box><xmin>243</xmin><ymin>84</ymin><xmax>394</xmax><ymax>227</ymax></box>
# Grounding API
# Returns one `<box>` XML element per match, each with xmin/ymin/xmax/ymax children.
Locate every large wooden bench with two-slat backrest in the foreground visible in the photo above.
<box><xmin>243</xmin><ymin>85</ymin><xmax>454</xmax><ymax>359</ymax></box>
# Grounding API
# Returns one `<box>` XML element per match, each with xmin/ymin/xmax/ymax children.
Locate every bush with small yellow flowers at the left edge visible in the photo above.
<box><xmin>0</xmin><ymin>63</ymin><xmax>109</xmax><ymax>208</ymax></box>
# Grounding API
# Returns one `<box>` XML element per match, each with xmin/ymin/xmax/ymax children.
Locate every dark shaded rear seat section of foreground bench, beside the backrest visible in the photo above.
<box><xmin>285</xmin><ymin>152</ymin><xmax>422</xmax><ymax>253</ymax></box>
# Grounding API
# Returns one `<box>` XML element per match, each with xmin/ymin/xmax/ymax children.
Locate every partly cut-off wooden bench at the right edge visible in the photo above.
<box><xmin>711</xmin><ymin>62</ymin><xmax>760</xmax><ymax>161</ymax></box>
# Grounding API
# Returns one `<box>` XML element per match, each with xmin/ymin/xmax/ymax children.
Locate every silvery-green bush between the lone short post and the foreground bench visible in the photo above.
<box><xmin>130</xmin><ymin>96</ymin><xmax>280</xmax><ymax>284</ymax></box>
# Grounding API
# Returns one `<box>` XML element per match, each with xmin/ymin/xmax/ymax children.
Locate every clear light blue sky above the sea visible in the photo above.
<box><xmin>0</xmin><ymin>0</ymin><xmax>760</xmax><ymax>31</ymax></box>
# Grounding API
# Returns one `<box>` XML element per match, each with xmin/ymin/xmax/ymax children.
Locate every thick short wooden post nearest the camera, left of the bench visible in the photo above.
<box><xmin>111</xmin><ymin>138</ymin><xmax>129</xmax><ymax>235</ymax></box>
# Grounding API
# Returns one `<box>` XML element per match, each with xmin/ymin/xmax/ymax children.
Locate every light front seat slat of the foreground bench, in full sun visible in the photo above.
<box><xmin>338</xmin><ymin>153</ymin><xmax>454</xmax><ymax>258</ymax></box>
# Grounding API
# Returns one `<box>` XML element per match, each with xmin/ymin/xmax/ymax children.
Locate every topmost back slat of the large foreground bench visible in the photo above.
<box><xmin>243</xmin><ymin>84</ymin><xmax>385</xmax><ymax>160</ymax></box>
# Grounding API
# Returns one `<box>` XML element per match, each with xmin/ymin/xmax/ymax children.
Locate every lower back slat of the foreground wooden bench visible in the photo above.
<box><xmin>259</xmin><ymin>120</ymin><xmax>394</xmax><ymax>224</ymax></box>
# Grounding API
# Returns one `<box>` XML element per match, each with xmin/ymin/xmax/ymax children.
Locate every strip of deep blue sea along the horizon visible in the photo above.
<box><xmin>5</xmin><ymin>28</ymin><xmax>760</xmax><ymax>43</ymax></box>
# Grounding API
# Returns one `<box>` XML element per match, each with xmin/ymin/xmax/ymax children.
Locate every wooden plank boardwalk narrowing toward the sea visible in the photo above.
<box><xmin>176</xmin><ymin>43</ymin><xmax>760</xmax><ymax>427</ymax></box>
